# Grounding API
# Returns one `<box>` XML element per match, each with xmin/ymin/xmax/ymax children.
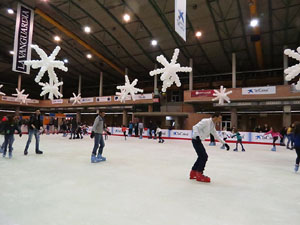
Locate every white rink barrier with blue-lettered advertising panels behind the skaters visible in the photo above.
<box><xmin>21</xmin><ymin>126</ymin><xmax>279</xmax><ymax>145</ymax></box>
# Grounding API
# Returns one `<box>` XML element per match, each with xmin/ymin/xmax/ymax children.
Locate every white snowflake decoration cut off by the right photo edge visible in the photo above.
<box><xmin>284</xmin><ymin>47</ymin><xmax>300</xmax><ymax>90</ymax></box>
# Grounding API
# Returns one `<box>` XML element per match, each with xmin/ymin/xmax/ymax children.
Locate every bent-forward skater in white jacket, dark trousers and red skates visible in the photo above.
<box><xmin>190</xmin><ymin>113</ymin><xmax>229</xmax><ymax>182</ymax></box>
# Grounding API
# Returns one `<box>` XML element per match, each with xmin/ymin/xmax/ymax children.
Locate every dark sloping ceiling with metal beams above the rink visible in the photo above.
<box><xmin>0</xmin><ymin>0</ymin><xmax>300</xmax><ymax>97</ymax></box>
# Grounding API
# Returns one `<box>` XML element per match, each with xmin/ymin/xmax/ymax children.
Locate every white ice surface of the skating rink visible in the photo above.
<box><xmin>0</xmin><ymin>135</ymin><xmax>300</xmax><ymax>225</ymax></box>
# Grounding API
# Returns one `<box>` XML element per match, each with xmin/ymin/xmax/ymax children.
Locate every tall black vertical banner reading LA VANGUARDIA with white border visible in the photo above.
<box><xmin>12</xmin><ymin>4</ymin><xmax>34</xmax><ymax>74</ymax></box>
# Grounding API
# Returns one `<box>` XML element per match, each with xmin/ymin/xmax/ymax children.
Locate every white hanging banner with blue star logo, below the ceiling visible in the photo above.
<box><xmin>175</xmin><ymin>0</ymin><xmax>186</xmax><ymax>41</ymax></box>
